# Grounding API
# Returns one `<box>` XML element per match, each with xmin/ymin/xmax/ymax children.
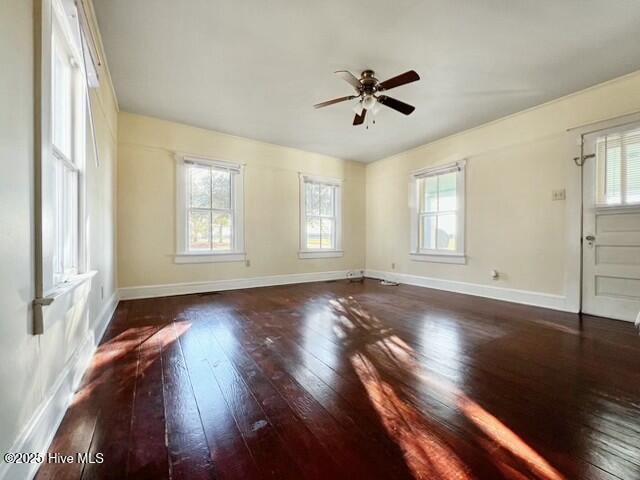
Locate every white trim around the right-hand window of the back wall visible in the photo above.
<box><xmin>298</xmin><ymin>173</ymin><xmax>344</xmax><ymax>259</ymax></box>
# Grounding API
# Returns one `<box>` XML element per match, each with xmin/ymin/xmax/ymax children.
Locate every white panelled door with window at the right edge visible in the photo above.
<box><xmin>582</xmin><ymin>125</ymin><xmax>640</xmax><ymax>320</ymax></box>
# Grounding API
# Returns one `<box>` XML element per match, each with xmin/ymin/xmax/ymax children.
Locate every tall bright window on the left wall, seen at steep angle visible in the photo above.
<box><xmin>42</xmin><ymin>2</ymin><xmax>86</xmax><ymax>289</ymax></box>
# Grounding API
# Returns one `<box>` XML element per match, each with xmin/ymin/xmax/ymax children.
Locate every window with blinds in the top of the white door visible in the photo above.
<box><xmin>596</xmin><ymin>129</ymin><xmax>640</xmax><ymax>205</ymax></box>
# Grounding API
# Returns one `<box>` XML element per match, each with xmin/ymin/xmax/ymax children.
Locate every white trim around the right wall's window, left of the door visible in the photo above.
<box><xmin>409</xmin><ymin>160</ymin><xmax>467</xmax><ymax>265</ymax></box>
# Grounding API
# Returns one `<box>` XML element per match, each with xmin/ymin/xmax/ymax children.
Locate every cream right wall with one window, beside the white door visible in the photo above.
<box><xmin>366</xmin><ymin>72</ymin><xmax>640</xmax><ymax>308</ymax></box>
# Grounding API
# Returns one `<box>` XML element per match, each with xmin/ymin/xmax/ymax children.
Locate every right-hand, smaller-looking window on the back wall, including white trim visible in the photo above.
<box><xmin>299</xmin><ymin>175</ymin><xmax>342</xmax><ymax>258</ymax></box>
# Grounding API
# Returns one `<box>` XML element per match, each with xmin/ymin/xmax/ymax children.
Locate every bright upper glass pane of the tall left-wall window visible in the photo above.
<box><xmin>51</xmin><ymin>37</ymin><xmax>72</xmax><ymax>158</ymax></box>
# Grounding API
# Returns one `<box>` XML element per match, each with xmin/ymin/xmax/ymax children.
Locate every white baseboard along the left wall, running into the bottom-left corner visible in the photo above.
<box><xmin>0</xmin><ymin>292</ymin><xmax>119</xmax><ymax>480</ymax></box>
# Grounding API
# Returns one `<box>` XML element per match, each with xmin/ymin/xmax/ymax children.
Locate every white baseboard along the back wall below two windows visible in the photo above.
<box><xmin>120</xmin><ymin>269</ymin><xmax>362</xmax><ymax>300</ymax></box>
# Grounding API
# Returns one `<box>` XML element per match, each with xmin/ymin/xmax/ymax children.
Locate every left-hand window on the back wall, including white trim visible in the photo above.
<box><xmin>176</xmin><ymin>156</ymin><xmax>245</xmax><ymax>263</ymax></box>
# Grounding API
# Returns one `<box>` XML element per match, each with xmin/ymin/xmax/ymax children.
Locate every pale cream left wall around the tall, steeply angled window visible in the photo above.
<box><xmin>0</xmin><ymin>0</ymin><xmax>117</xmax><ymax>464</ymax></box>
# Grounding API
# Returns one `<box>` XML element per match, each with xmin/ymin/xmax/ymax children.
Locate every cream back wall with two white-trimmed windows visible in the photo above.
<box><xmin>118</xmin><ymin>112</ymin><xmax>365</xmax><ymax>287</ymax></box>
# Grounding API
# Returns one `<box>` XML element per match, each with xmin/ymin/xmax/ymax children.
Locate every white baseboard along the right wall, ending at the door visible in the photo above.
<box><xmin>365</xmin><ymin>270</ymin><xmax>577</xmax><ymax>313</ymax></box>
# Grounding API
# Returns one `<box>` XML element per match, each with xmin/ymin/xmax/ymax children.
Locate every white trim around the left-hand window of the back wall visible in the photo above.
<box><xmin>174</xmin><ymin>153</ymin><xmax>247</xmax><ymax>264</ymax></box>
